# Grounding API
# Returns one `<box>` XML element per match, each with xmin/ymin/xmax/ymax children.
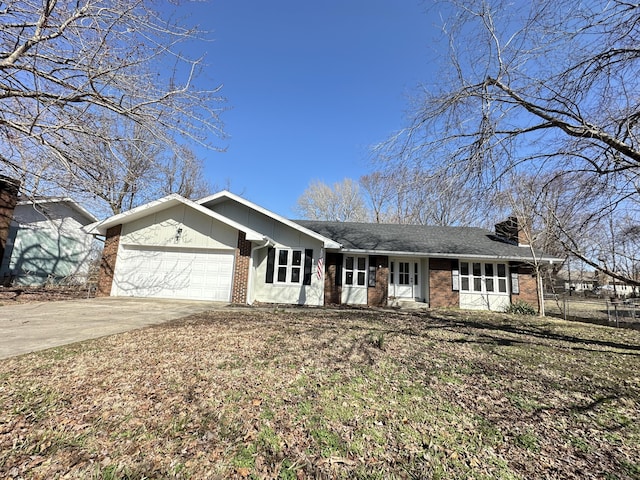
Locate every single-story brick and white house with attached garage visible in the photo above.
<box><xmin>88</xmin><ymin>191</ymin><xmax>561</xmax><ymax>310</ymax></box>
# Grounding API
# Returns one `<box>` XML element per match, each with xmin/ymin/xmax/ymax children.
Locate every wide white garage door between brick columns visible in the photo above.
<box><xmin>111</xmin><ymin>247</ymin><xmax>234</xmax><ymax>302</ymax></box>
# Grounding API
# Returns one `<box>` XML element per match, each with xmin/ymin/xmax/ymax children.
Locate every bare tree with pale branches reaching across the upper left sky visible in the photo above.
<box><xmin>0</xmin><ymin>0</ymin><xmax>222</xmax><ymax>198</ymax></box>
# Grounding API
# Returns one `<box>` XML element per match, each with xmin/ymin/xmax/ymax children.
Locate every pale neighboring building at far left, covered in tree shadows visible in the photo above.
<box><xmin>0</xmin><ymin>193</ymin><xmax>97</xmax><ymax>286</ymax></box>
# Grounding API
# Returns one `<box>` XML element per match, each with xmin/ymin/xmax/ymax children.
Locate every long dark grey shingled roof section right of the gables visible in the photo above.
<box><xmin>296</xmin><ymin>220</ymin><xmax>561</xmax><ymax>262</ymax></box>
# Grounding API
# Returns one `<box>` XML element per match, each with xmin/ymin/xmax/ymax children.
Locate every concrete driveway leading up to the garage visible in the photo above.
<box><xmin>0</xmin><ymin>297</ymin><xmax>226</xmax><ymax>359</ymax></box>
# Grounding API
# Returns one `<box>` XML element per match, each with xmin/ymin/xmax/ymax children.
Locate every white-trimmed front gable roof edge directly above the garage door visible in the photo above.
<box><xmin>85</xmin><ymin>193</ymin><xmax>267</xmax><ymax>241</ymax></box>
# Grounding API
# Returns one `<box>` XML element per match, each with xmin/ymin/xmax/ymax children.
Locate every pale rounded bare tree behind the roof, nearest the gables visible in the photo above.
<box><xmin>296</xmin><ymin>178</ymin><xmax>370</xmax><ymax>222</ymax></box>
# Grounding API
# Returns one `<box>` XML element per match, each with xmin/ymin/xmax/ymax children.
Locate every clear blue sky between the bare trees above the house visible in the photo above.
<box><xmin>186</xmin><ymin>0</ymin><xmax>436</xmax><ymax>217</ymax></box>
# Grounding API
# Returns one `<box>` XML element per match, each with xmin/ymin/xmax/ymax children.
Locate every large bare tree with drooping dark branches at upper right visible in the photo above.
<box><xmin>380</xmin><ymin>0</ymin><xmax>640</xmax><ymax>283</ymax></box>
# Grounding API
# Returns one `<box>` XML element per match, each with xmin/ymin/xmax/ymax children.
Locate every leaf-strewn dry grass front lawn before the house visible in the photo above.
<box><xmin>0</xmin><ymin>308</ymin><xmax>640</xmax><ymax>479</ymax></box>
